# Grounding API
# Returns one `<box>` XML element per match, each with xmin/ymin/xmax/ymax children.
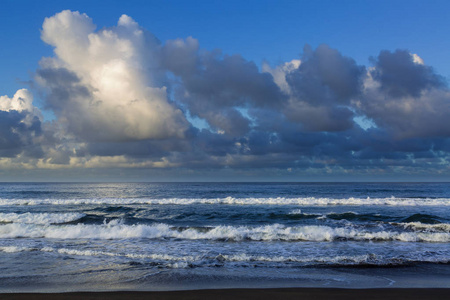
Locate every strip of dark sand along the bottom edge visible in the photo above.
<box><xmin>0</xmin><ymin>288</ymin><xmax>450</xmax><ymax>300</ymax></box>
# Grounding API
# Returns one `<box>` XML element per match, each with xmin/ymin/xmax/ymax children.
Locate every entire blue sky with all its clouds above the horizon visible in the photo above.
<box><xmin>0</xmin><ymin>0</ymin><xmax>450</xmax><ymax>181</ymax></box>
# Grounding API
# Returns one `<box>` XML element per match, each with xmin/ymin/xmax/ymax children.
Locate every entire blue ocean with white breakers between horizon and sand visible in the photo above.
<box><xmin>0</xmin><ymin>183</ymin><xmax>450</xmax><ymax>292</ymax></box>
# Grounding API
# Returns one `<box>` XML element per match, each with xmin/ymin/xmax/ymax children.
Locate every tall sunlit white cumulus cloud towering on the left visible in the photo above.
<box><xmin>37</xmin><ymin>10</ymin><xmax>188</xmax><ymax>141</ymax></box>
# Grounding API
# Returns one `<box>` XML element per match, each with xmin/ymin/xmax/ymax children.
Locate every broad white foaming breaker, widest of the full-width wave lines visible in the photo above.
<box><xmin>0</xmin><ymin>220</ymin><xmax>450</xmax><ymax>243</ymax></box>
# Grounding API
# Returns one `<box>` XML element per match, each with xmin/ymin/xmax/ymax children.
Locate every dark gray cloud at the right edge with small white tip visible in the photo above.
<box><xmin>359</xmin><ymin>50</ymin><xmax>450</xmax><ymax>138</ymax></box>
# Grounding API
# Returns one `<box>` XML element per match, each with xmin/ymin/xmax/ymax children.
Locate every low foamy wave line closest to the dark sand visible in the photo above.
<box><xmin>0</xmin><ymin>246</ymin><xmax>450</xmax><ymax>268</ymax></box>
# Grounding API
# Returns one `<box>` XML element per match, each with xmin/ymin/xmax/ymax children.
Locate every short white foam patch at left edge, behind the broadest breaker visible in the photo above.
<box><xmin>0</xmin><ymin>212</ymin><xmax>86</xmax><ymax>224</ymax></box>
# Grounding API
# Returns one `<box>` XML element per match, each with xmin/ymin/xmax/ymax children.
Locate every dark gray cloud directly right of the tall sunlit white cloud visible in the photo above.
<box><xmin>162</xmin><ymin>38</ymin><xmax>287</xmax><ymax>136</ymax></box>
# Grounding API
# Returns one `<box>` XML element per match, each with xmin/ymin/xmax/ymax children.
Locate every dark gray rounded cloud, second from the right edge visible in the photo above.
<box><xmin>285</xmin><ymin>45</ymin><xmax>365</xmax><ymax>131</ymax></box>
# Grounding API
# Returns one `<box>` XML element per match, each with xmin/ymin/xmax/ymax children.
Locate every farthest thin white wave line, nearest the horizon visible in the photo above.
<box><xmin>0</xmin><ymin>197</ymin><xmax>450</xmax><ymax>206</ymax></box>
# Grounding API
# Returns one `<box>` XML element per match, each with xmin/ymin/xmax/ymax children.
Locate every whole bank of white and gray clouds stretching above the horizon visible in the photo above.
<box><xmin>0</xmin><ymin>11</ymin><xmax>450</xmax><ymax>180</ymax></box>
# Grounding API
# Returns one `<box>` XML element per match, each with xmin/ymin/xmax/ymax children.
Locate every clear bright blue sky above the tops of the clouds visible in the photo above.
<box><xmin>0</xmin><ymin>0</ymin><xmax>450</xmax><ymax>95</ymax></box>
